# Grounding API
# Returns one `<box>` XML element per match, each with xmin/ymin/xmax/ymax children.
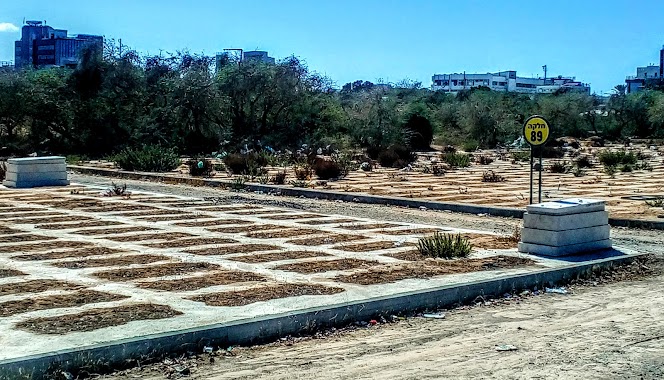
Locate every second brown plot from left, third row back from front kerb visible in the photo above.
<box><xmin>93</xmin><ymin>262</ymin><xmax>219</xmax><ymax>281</ymax></box>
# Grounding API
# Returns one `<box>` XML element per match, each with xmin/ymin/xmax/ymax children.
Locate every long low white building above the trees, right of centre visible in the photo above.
<box><xmin>431</xmin><ymin>71</ymin><xmax>590</xmax><ymax>94</ymax></box>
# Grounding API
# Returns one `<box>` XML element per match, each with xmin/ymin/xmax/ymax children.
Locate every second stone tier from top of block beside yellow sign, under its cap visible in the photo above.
<box><xmin>523</xmin><ymin>211</ymin><xmax>609</xmax><ymax>231</ymax></box>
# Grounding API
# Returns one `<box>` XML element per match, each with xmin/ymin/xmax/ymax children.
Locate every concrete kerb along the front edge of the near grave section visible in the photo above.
<box><xmin>0</xmin><ymin>254</ymin><xmax>641</xmax><ymax>379</ymax></box>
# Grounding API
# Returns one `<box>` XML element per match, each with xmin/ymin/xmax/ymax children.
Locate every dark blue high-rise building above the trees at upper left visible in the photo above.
<box><xmin>14</xmin><ymin>21</ymin><xmax>104</xmax><ymax>68</ymax></box>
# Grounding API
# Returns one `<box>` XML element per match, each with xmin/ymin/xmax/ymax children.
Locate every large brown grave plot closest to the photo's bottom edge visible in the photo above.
<box><xmin>16</xmin><ymin>304</ymin><xmax>183</xmax><ymax>335</ymax></box>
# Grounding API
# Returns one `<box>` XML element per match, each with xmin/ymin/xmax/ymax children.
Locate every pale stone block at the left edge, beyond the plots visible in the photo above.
<box><xmin>2</xmin><ymin>156</ymin><xmax>69</xmax><ymax>188</ymax></box>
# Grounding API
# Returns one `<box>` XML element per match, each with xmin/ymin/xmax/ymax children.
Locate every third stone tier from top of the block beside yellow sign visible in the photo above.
<box><xmin>521</xmin><ymin>224</ymin><xmax>611</xmax><ymax>247</ymax></box>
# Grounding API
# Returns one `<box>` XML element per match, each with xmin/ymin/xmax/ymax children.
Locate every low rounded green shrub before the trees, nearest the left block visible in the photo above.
<box><xmin>113</xmin><ymin>145</ymin><xmax>181</xmax><ymax>172</ymax></box>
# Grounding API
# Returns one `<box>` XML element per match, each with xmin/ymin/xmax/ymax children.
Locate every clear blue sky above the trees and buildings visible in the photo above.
<box><xmin>0</xmin><ymin>0</ymin><xmax>664</xmax><ymax>93</ymax></box>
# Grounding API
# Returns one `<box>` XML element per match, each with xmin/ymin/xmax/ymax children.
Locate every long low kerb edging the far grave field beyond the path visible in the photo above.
<box><xmin>67</xmin><ymin>165</ymin><xmax>664</xmax><ymax>230</ymax></box>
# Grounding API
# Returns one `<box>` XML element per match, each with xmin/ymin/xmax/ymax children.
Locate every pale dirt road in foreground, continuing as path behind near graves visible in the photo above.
<box><xmin>62</xmin><ymin>175</ymin><xmax>664</xmax><ymax>380</ymax></box>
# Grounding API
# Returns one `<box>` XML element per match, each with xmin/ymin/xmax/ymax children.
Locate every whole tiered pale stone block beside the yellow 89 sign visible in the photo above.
<box><xmin>519</xmin><ymin>198</ymin><xmax>611</xmax><ymax>256</ymax></box>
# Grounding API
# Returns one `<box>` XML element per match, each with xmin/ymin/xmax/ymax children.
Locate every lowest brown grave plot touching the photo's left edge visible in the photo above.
<box><xmin>0</xmin><ymin>290</ymin><xmax>129</xmax><ymax>317</ymax></box>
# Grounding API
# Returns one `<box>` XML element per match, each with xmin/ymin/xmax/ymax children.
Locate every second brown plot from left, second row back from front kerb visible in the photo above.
<box><xmin>138</xmin><ymin>271</ymin><xmax>267</xmax><ymax>291</ymax></box>
